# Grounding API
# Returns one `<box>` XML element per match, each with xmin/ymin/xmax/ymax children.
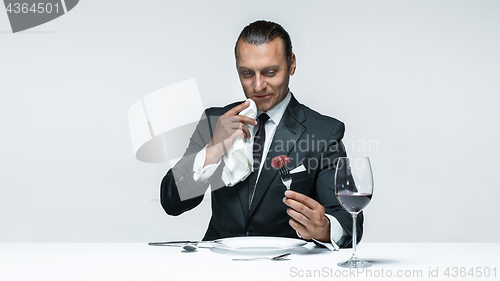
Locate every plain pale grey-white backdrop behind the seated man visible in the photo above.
<box><xmin>0</xmin><ymin>0</ymin><xmax>500</xmax><ymax>242</ymax></box>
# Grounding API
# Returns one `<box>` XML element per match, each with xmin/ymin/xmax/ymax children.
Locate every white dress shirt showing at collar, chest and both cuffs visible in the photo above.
<box><xmin>193</xmin><ymin>92</ymin><xmax>344</xmax><ymax>251</ymax></box>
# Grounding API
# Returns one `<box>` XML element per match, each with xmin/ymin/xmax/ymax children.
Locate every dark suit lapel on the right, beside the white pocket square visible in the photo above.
<box><xmin>248</xmin><ymin>95</ymin><xmax>306</xmax><ymax>220</ymax></box>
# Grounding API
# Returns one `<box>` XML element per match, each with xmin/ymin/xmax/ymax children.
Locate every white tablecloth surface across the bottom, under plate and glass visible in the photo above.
<box><xmin>0</xmin><ymin>243</ymin><xmax>500</xmax><ymax>281</ymax></box>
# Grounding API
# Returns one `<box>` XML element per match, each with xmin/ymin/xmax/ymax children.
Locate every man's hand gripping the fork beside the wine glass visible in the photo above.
<box><xmin>283</xmin><ymin>190</ymin><xmax>330</xmax><ymax>242</ymax></box>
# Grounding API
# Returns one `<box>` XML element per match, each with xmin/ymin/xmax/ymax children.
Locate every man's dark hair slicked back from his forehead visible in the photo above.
<box><xmin>234</xmin><ymin>20</ymin><xmax>293</xmax><ymax>68</ymax></box>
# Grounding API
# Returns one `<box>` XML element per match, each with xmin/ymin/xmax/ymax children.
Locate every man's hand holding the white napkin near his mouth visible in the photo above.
<box><xmin>203</xmin><ymin>101</ymin><xmax>257</xmax><ymax>166</ymax></box>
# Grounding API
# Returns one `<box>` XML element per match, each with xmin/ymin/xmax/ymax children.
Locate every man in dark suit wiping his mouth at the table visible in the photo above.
<box><xmin>160</xmin><ymin>21</ymin><xmax>363</xmax><ymax>249</ymax></box>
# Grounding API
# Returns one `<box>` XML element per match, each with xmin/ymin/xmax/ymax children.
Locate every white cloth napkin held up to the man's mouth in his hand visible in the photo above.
<box><xmin>222</xmin><ymin>99</ymin><xmax>257</xmax><ymax>187</ymax></box>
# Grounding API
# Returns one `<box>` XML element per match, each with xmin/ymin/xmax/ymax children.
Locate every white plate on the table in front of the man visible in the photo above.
<box><xmin>212</xmin><ymin>236</ymin><xmax>307</xmax><ymax>254</ymax></box>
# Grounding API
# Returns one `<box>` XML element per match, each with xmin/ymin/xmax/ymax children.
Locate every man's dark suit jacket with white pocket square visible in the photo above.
<box><xmin>160</xmin><ymin>95</ymin><xmax>363</xmax><ymax>247</ymax></box>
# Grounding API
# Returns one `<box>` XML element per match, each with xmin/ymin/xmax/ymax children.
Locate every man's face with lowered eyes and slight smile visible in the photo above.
<box><xmin>236</xmin><ymin>38</ymin><xmax>295</xmax><ymax>111</ymax></box>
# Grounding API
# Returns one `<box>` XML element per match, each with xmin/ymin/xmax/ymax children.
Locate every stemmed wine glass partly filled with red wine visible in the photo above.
<box><xmin>334</xmin><ymin>157</ymin><xmax>373</xmax><ymax>268</ymax></box>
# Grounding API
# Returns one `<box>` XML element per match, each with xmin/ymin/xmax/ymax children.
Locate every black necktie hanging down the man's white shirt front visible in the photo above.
<box><xmin>248</xmin><ymin>113</ymin><xmax>269</xmax><ymax>208</ymax></box>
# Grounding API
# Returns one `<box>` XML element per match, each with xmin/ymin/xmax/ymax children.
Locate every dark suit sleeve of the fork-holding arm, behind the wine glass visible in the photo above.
<box><xmin>316</xmin><ymin>122</ymin><xmax>363</xmax><ymax>248</ymax></box>
